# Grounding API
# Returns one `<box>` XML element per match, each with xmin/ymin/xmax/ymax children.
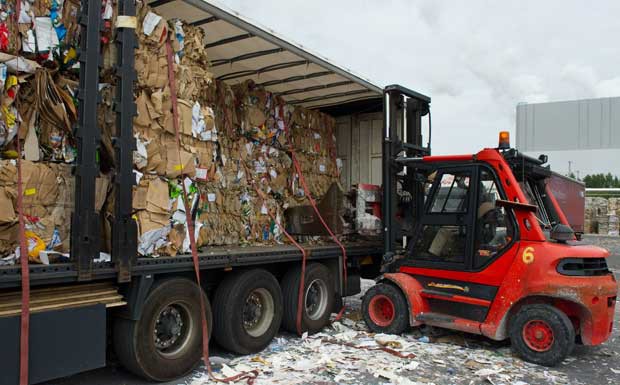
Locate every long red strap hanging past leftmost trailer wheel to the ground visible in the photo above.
<box><xmin>166</xmin><ymin>36</ymin><xmax>258</xmax><ymax>384</ymax></box>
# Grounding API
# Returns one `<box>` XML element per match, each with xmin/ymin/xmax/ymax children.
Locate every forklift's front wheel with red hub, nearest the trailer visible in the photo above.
<box><xmin>362</xmin><ymin>283</ymin><xmax>409</xmax><ymax>334</ymax></box>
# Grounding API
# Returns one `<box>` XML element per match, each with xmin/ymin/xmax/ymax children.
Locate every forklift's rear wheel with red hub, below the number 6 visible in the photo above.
<box><xmin>510</xmin><ymin>304</ymin><xmax>575</xmax><ymax>366</ymax></box>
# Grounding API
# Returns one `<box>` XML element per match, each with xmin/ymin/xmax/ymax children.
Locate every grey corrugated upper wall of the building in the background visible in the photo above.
<box><xmin>516</xmin><ymin>97</ymin><xmax>620</xmax><ymax>151</ymax></box>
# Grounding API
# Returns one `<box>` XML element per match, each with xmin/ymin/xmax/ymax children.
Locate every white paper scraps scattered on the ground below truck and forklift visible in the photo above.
<box><xmin>186</xmin><ymin>281</ymin><xmax>592</xmax><ymax>385</ymax></box>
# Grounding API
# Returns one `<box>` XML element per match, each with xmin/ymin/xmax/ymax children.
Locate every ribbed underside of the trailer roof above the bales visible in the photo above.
<box><xmin>148</xmin><ymin>0</ymin><xmax>383</xmax><ymax>109</ymax></box>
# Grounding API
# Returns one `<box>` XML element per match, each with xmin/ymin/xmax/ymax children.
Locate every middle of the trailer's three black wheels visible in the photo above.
<box><xmin>213</xmin><ymin>269</ymin><xmax>282</xmax><ymax>354</ymax></box>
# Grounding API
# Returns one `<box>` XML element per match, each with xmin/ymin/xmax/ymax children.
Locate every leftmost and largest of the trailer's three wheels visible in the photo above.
<box><xmin>113</xmin><ymin>278</ymin><xmax>213</xmax><ymax>382</ymax></box>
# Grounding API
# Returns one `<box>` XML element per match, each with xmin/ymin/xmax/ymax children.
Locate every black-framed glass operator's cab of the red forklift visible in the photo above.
<box><xmin>405</xmin><ymin>163</ymin><xmax>516</xmax><ymax>271</ymax></box>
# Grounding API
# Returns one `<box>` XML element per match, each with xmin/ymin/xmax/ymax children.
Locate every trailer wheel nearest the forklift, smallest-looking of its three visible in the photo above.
<box><xmin>282</xmin><ymin>263</ymin><xmax>336</xmax><ymax>333</ymax></box>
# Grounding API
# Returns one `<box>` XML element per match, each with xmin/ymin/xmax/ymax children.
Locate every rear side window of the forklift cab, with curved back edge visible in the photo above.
<box><xmin>474</xmin><ymin>168</ymin><xmax>514</xmax><ymax>269</ymax></box>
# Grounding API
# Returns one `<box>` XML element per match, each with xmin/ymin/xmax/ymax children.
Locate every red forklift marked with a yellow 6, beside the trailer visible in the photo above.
<box><xmin>362</xmin><ymin>86</ymin><xmax>617</xmax><ymax>366</ymax></box>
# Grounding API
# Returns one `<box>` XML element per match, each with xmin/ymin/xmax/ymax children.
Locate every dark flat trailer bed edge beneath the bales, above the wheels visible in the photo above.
<box><xmin>0</xmin><ymin>241</ymin><xmax>382</xmax><ymax>289</ymax></box>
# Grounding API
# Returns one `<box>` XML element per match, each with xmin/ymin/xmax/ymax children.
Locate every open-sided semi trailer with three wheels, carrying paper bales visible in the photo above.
<box><xmin>0</xmin><ymin>0</ymin><xmax>382</xmax><ymax>384</ymax></box>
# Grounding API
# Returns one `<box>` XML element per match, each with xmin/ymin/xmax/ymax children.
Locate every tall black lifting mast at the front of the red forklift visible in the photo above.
<box><xmin>383</xmin><ymin>85</ymin><xmax>431</xmax><ymax>261</ymax></box>
